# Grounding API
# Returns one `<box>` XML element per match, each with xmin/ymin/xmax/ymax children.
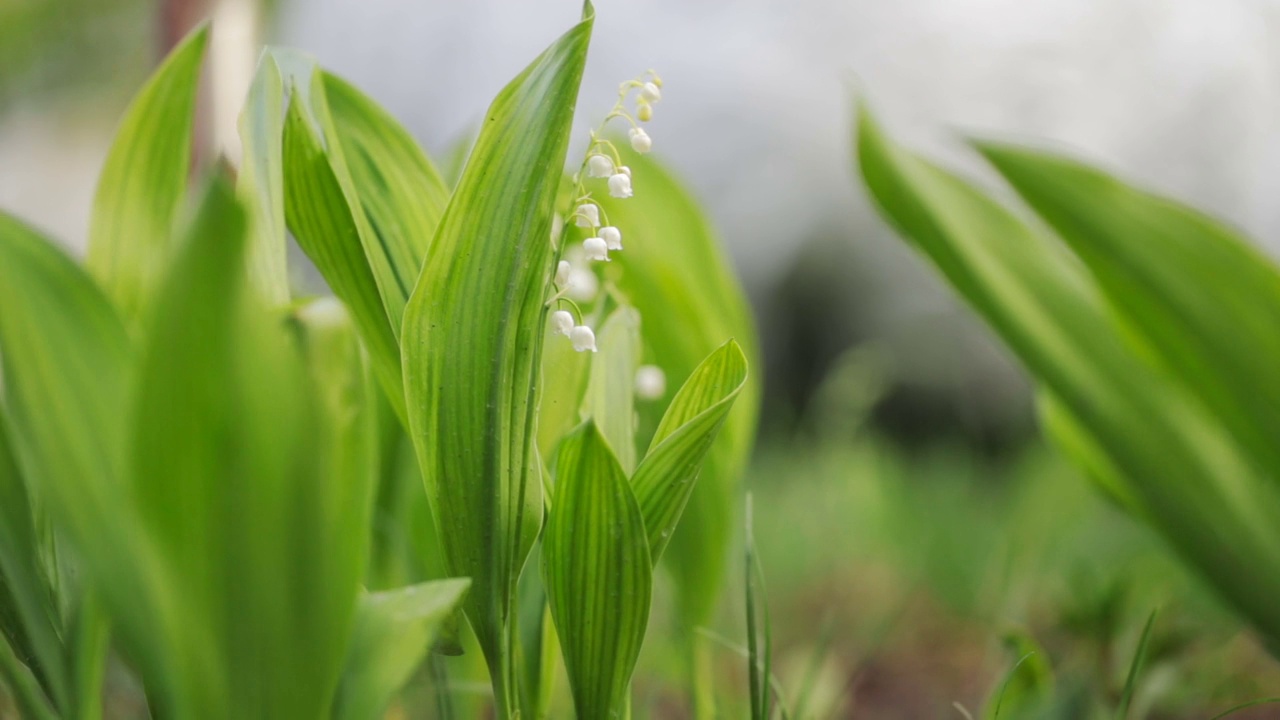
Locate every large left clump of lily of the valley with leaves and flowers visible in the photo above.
<box><xmin>0</xmin><ymin>5</ymin><xmax>758</xmax><ymax>720</ymax></box>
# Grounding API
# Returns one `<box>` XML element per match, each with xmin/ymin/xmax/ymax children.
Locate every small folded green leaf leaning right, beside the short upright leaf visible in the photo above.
<box><xmin>631</xmin><ymin>341</ymin><xmax>748</xmax><ymax>562</ymax></box>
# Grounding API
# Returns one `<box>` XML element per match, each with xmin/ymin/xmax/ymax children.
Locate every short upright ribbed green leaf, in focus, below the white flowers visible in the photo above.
<box><xmin>543</xmin><ymin>420</ymin><xmax>653</xmax><ymax>717</ymax></box>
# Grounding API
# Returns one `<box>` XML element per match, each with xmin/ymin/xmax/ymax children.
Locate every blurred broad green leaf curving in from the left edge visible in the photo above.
<box><xmin>0</xmin><ymin>214</ymin><xmax>168</xmax><ymax>712</ymax></box>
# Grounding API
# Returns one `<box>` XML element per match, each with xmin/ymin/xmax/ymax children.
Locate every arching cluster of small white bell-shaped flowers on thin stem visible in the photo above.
<box><xmin>550</xmin><ymin>70</ymin><xmax>662</xmax><ymax>353</ymax></box>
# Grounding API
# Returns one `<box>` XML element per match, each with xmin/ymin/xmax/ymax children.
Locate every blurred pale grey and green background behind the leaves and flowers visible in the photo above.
<box><xmin>0</xmin><ymin>0</ymin><xmax>1280</xmax><ymax>717</ymax></box>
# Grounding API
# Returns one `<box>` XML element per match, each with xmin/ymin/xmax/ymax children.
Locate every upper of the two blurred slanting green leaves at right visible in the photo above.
<box><xmin>978</xmin><ymin>143</ymin><xmax>1280</xmax><ymax>474</ymax></box>
